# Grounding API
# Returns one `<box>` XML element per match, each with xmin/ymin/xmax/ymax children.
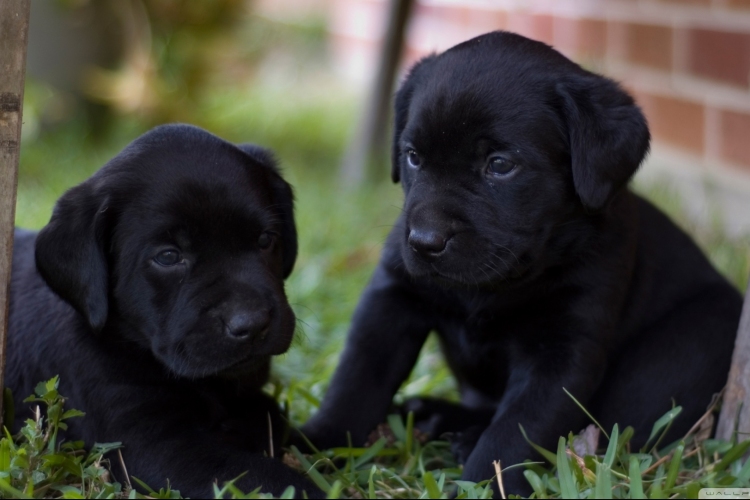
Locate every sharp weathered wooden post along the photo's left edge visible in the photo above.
<box><xmin>0</xmin><ymin>0</ymin><xmax>31</xmax><ymax>426</ymax></box>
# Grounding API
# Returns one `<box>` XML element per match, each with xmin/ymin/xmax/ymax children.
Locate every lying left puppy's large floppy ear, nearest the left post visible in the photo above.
<box><xmin>35</xmin><ymin>179</ymin><xmax>109</xmax><ymax>333</ymax></box>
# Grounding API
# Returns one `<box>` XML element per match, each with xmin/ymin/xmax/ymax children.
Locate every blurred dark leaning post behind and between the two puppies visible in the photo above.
<box><xmin>343</xmin><ymin>0</ymin><xmax>414</xmax><ymax>184</ymax></box>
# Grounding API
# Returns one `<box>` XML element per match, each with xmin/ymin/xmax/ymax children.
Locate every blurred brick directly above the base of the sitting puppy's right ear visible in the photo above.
<box><xmin>553</xmin><ymin>17</ymin><xmax>607</xmax><ymax>58</ymax></box>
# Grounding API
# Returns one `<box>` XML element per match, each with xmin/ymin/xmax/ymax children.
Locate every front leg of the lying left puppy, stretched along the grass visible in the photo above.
<box><xmin>98</xmin><ymin>388</ymin><xmax>325</xmax><ymax>498</ymax></box>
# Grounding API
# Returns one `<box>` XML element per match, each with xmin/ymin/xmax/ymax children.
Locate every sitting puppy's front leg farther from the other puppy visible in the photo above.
<box><xmin>463</xmin><ymin>342</ymin><xmax>605</xmax><ymax>495</ymax></box>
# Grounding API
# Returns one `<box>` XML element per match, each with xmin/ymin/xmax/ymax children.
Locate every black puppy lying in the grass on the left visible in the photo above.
<box><xmin>6</xmin><ymin>125</ymin><xmax>320</xmax><ymax>497</ymax></box>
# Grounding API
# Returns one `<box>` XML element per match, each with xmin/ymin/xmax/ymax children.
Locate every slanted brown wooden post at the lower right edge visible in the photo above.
<box><xmin>707</xmin><ymin>286</ymin><xmax>750</xmax><ymax>442</ymax></box>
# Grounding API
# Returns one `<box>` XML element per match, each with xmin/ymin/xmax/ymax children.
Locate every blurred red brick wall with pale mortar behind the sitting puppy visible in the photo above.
<box><xmin>329</xmin><ymin>0</ymin><xmax>750</xmax><ymax>179</ymax></box>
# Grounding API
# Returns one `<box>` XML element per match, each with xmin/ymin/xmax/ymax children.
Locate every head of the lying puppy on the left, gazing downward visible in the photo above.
<box><xmin>36</xmin><ymin>125</ymin><xmax>297</xmax><ymax>377</ymax></box>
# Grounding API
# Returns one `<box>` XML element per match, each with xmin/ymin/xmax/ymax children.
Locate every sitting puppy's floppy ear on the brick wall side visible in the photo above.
<box><xmin>557</xmin><ymin>74</ymin><xmax>650</xmax><ymax>210</ymax></box>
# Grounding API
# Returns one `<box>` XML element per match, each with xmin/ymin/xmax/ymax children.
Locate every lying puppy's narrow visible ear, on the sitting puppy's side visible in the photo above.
<box><xmin>237</xmin><ymin>144</ymin><xmax>297</xmax><ymax>279</ymax></box>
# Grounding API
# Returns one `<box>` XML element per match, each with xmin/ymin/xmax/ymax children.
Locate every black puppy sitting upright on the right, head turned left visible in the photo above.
<box><xmin>303</xmin><ymin>32</ymin><xmax>741</xmax><ymax>492</ymax></box>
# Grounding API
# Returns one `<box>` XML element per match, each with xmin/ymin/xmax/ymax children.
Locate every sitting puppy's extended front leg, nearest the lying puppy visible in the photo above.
<box><xmin>302</xmin><ymin>264</ymin><xmax>431</xmax><ymax>448</ymax></box>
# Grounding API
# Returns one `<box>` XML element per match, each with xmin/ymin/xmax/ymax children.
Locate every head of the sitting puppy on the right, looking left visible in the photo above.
<box><xmin>392</xmin><ymin>32</ymin><xmax>649</xmax><ymax>286</ymax></box>
